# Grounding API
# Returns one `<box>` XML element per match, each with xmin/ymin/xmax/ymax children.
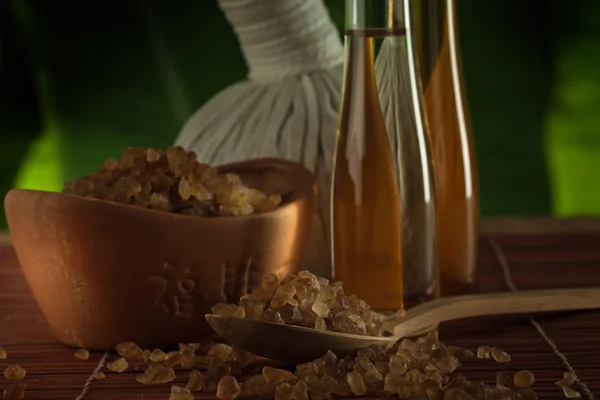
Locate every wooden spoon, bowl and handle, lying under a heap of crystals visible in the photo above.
<box><xmin>206</xmin><ymin>287</ymin><xmax>600</xmax><ymax>363</ymax></box>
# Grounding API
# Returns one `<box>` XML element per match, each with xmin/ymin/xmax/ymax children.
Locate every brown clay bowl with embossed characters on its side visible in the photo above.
<box><xmin>4</xmin><ymin>159</ymin><xmax>316</xmax><ymax>350</ymax></box>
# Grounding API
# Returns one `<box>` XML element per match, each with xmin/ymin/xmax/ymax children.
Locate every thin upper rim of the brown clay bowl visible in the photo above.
<box><xmin>4</xmin><ymin>157</ymin><xmax>317</xmax><ymax>223</ymax></box>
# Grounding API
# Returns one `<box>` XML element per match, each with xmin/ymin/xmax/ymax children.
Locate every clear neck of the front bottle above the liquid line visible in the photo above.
<box><xmin>346</xmin><ymin>0</ymin><xmax>411</xmax><ymax>31</ymax></box>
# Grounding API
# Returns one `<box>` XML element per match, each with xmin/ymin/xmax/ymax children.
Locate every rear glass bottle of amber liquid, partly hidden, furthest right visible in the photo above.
<box><xmin>415</xmin><ymin>0</ymin><xmax>479</xmax><ymax>296</ymax></box>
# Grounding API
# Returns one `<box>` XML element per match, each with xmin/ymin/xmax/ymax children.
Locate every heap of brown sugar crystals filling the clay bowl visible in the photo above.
<box><xmin>63</xmin><ymin>146</ymin><xmax>281</xmax><ymax>217</ymax></box>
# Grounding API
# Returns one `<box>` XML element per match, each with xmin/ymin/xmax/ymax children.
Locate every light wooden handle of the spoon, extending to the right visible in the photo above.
<box><xmin>385</xmin><ymin>287</ymin><xmax>600</xmax><ymax>337</ymax></box>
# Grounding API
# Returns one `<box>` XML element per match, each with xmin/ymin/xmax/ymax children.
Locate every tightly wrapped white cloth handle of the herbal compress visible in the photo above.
<box><xmin>219</xmin><ymin>0</ymin><xmax>343</xmax><ymax>82</ymax></box>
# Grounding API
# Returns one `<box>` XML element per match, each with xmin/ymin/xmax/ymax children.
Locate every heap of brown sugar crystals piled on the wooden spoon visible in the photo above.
<box><xmin>212</xmin><ymin>271</ymin><xmax>383</xmax><ymax>336</ymax></box>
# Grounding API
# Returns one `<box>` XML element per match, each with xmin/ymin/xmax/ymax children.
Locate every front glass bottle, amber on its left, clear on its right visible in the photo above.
<box><xmin>332</xmin><ymin>0</ymin><xmax>438</xmax><ymax>311</ymax></box>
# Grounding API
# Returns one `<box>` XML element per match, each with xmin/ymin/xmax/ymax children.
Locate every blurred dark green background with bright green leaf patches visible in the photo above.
<box><xmin>0</xmin><ymin>0</ymin><xmax>600</xmax><ymax>228</ymax></box>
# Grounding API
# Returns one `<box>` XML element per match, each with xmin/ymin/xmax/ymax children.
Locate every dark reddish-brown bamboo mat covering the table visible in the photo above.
<box><xmin>0</xmin><ymin>233</ymin><xmax>600</xmax><ymax>400</ymax></box>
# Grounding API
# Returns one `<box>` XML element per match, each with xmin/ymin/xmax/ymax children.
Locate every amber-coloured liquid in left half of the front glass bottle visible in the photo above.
<box><xmin>332</xmin><ymin>28</ymin><xmax>403</xmax><ymax>311</ymax></box>
